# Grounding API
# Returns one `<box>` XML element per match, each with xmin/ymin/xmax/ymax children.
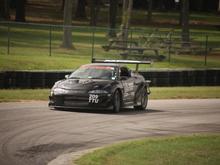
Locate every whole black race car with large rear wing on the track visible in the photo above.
<box><xmin>49</xmin><ymin>60</ymin><xmax>150</xmax><ymax>112</ymax></box>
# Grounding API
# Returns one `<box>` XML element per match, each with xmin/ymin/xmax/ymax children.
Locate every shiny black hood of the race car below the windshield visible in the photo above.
<box><xmin>56</xmin><ymin>79</ymin><xmax>113</xmax><ymax>90</ymax></box>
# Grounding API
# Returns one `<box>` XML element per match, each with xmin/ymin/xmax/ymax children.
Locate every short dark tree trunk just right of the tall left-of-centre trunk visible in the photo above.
<box><xmin>75</xmin><ymin>0</ymin><xmax>86</xmax><ymax>20</ymax></box>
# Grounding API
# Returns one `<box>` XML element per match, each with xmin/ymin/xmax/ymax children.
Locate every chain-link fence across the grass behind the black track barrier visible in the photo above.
<box><xmin>0</xmin><ymin>22</ymin><xmax>220</xmax><ymax>67</ymax></box>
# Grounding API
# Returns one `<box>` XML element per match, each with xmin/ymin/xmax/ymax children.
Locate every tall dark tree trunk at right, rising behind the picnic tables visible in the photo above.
<box><xmin>181</xmin><ymin>0</ymin><xmax>190</xmax><ymax>47</ymax></box>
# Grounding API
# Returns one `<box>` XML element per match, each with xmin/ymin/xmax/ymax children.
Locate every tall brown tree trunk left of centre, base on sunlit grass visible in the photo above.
<box><xmin>62</xmin><ymin>0</ymin><xmax>73</xmax><ymax>49</ymax></box>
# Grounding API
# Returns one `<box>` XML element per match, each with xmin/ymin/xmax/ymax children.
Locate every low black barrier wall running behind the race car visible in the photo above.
<box><xmin>0</xmin><ymin>69</ymin><xmax>220</xmax><ymax>89</ymax></box>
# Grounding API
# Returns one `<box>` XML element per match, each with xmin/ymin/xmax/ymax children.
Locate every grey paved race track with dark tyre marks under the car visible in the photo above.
<box><xmin>0</xmin><ymin>99</ymin><xmax>220</xmax><ymax>165</ymax></box>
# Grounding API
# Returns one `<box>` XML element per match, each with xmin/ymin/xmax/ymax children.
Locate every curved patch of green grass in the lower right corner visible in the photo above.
<box><xmin>76</xmin><ymin>134</ymin><xmax>220</xmax><ymax>165</ymax></box>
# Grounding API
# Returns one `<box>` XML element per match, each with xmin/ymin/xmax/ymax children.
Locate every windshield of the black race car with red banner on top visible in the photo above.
<box><xmin>69</xmin><ymin>65</ymin><xmax>116</xmax><ymax>80</ymax></box>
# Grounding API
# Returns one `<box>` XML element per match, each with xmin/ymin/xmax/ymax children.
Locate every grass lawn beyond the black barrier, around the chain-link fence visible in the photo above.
<box><xmin>0</xmin><ymin>24</ymin><xmax>220</xmax><ymax>70</ymax></box>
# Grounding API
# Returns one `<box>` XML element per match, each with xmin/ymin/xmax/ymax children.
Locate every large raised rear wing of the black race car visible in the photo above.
<box><xmin>92</xmin><ymin>58</ymin><xmax>152</xmax><ymax>71</ymax></box>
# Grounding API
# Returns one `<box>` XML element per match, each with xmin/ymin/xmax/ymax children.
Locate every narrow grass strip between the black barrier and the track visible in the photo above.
<box><xmin>0</xmin><ymin>87</ymin><xmax>220</xmax><ymax>102</ymax></box>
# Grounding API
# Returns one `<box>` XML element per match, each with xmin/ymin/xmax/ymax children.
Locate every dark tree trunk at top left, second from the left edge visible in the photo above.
<box><xmin>15</xmin><ymin>0</ymin><xmax>26</xmax><ymax>22</ymax></box>
